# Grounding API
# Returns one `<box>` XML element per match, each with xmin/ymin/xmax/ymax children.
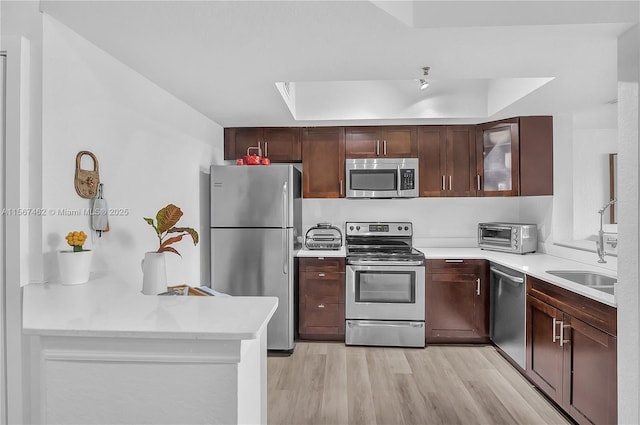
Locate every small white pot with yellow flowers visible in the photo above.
<box><xmin>58</xmin><ymin>231</ymin><xmax>93</xmax><ymax>285</ymax></box>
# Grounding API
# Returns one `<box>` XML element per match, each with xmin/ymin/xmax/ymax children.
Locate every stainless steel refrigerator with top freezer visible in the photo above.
<box><xmin>211</xmin><ymin>164</ymin><xmax>302</xmax><ymax>350</ymax></box>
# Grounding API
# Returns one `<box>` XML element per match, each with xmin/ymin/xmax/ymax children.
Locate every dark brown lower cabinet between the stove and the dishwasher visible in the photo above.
<box><xmin>425</xmin><ymin>259</ymin><xmax>489</xmax><ymax>343</ymax></box>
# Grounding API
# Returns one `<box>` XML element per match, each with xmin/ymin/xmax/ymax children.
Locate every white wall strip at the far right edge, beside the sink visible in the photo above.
<box><xmin>616</xmin><ymin>25</ymin><xmax>640</xmax><ymax>424</ymax></box>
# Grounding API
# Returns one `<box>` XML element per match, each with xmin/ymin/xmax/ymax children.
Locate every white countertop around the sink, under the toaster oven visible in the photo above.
<box><xmin>416</xmin><ymin>246</ymin><xmax>617</xmax><ymax>307</ymax></box>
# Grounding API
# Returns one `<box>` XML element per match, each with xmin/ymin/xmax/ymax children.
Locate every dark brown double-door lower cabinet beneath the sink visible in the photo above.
<box><xmin>527</xmin><ymin>276</ymin><xmax>617</xmax><ymax>425</ymax></box>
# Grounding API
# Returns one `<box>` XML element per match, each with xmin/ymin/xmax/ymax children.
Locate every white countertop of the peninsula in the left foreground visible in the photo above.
<box><xmin>23</xmin><ymin>277</ymin><xmax>278</xmax><ymax>340</ymax></box>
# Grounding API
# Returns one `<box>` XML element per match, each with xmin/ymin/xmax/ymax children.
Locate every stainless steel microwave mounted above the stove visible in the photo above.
<box><xmin>345</xmin><ymin>158</ymin><xmax>418</xmax><ymax>198</ymax></box>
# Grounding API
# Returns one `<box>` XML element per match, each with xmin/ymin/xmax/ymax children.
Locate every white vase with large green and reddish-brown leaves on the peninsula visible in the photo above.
<box><xmin>142</xmin><ymin>204</ymin><xmax>199</xmax><ymax>295</ymax></box>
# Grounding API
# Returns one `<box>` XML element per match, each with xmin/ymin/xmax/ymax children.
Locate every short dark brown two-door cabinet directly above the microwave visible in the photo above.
<box><xmin>345</xmin><ymin>126</ymin><xmax>418</xmax><ymax>158</ymax></box>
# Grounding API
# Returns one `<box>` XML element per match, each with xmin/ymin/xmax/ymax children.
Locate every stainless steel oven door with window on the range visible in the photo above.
<box><xmin>345</xmin><ymin>265</ymin><xmax>425</xmax><ymax>321</ymax></box>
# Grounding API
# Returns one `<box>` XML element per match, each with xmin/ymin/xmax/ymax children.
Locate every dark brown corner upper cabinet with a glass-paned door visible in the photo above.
<box><xmin>476</xmin><ymin>116</ymin><xmax>553</xmax><ymax>196</ymax></box>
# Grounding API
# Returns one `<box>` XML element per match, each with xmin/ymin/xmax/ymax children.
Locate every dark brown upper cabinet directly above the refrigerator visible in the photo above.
<box><xmin>224</xmin><ymin>127</ymin><xmax>302</xmax><ymax>162</ymax></box>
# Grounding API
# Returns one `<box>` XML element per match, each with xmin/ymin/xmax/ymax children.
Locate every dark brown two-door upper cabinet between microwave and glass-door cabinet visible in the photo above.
<box><xmin>418</xmin><ymin>125</ymin><xmax>477</xmax><ymax>196</ymax></box>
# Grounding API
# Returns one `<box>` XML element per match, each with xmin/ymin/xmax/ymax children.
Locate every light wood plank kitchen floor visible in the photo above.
<box><xmin>267</xmin><ymin>342</ymin><xmax>569</xmax><ymax>425</ymax></box>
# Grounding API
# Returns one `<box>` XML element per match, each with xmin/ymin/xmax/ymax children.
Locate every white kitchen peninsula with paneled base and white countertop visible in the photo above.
<box><xmin>23</xmin><ymin>277</ymin><xmax>278</xmax><ymax>424</ymax></box>
